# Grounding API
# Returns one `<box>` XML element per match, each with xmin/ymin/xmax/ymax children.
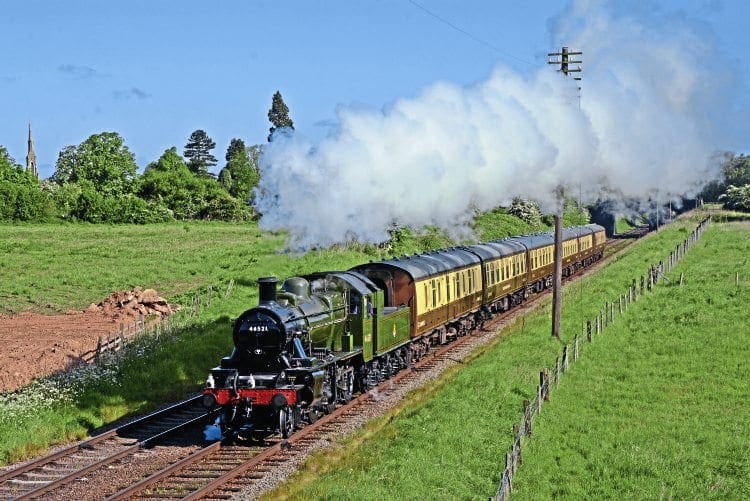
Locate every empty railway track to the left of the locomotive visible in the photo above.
<box><xmin>0</xmin><ymin>396</ymin><xmax>212</xmax><ymax>499</ymax></box>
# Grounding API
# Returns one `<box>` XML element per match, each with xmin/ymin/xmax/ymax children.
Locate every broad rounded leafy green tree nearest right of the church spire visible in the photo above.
<box><xmin>52</xmin><ymin>132</ymin><xmax>138</xmax><ymax>197</ymax></box>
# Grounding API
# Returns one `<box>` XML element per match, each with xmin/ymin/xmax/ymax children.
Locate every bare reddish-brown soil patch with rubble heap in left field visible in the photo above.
<box><xmin>0</xmin><ymin>287</ymin><xmax>179</xmax><ymax>392</ymax></box>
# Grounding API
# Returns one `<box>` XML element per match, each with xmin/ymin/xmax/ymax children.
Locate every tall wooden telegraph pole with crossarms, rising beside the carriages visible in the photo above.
<box><xmin>547</xmin><ymin>47</ymin><xmax>583</xmax><ymax>339</ymax></box>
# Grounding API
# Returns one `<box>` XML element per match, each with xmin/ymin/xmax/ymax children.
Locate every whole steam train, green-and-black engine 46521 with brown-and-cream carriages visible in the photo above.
<box><xmin>203</xmin><ymin>224</ymin><xmax>606</xmax><ymax>441</ymax></box>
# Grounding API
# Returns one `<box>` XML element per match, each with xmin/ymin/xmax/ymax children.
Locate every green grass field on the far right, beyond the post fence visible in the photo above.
<box><xmin>513</xmin><ymin>223</ymin><xmax>750</xmax><ymax>499</ymax></box>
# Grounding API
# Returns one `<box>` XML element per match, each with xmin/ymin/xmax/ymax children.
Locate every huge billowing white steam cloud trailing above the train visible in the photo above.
<box><xmin>256</xmin><ymin>1</ymin><xmax>734</xmax><ymax>248</ymax></box>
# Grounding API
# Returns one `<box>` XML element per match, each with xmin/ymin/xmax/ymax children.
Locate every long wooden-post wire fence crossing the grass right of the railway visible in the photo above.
<box><xmin>490</xmin><ymin>216</ymin><xmax>712</xmax><ymax>501</ymax></box>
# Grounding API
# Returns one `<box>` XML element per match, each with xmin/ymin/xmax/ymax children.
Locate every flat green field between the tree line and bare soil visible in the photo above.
<box><xmin>0</xmin><ymin>222</ymin><xmax>274</xmax><ymax>313</ymax></box>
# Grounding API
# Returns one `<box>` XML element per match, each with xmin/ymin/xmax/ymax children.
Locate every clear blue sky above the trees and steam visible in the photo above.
<box><xmin>0</xmin><ymin>0</ymin><xmax>750</xmax><ymax>177</ymax></box>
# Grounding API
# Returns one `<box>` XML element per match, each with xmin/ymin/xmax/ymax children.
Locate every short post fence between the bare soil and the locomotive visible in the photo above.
<box><xmin>81</xmin><ymin>279</ymin><xmax>234</xmax><ymax>363</ymax></box>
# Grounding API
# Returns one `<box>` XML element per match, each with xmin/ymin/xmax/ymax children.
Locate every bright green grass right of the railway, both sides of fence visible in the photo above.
<box><xmin>267</xmin><ymin>212</ymin><xmax>750</xmax><ymax>499</ymax></box>
